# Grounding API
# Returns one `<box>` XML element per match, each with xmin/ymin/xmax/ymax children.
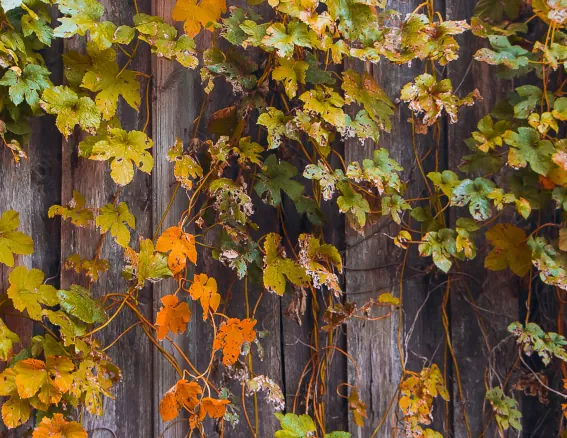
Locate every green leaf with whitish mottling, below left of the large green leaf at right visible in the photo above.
<box><xmin>451</xmin><ymin>178</ymin><xmax>496</xmax><ymax>221</ymax></box>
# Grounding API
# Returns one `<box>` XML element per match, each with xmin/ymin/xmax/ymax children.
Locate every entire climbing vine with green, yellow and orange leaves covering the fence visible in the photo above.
<box><xmin>0</xmin><ymin>0</ymin><xmax>567</xmax><ymax>438</ymax></box>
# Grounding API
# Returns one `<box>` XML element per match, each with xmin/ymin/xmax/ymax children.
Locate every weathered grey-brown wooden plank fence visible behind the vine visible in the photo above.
<box><xmin>0</xmin><ymin>0</ymin><xmax>559</xmax><ymax>438</ymax></box>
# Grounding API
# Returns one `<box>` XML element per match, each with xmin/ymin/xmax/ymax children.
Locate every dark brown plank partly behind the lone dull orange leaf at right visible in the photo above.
<box><xmin>446</xmin><ymin>0</ymin><xmax>522</xmax><ymax>437</ymax></box>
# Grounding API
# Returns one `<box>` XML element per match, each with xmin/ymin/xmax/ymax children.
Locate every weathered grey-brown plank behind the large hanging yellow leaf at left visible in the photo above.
<box><xmin>61</xmin><ymin>0</ymin><xmax>154</xmax><ymax>438</ymax></box>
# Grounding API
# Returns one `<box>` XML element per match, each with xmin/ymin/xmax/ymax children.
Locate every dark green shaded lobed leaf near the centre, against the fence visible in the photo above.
<box><xmin>254</xmin><ymin>155</ymin><xmax>303</xmax><ymax>206</ymax></box>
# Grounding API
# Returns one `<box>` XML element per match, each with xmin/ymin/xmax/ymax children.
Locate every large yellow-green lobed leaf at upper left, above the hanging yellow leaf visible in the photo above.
<box><xmin>81</xmin><ymin>45</ymin><xmax>141</xmax><ymax>120</ymax></box>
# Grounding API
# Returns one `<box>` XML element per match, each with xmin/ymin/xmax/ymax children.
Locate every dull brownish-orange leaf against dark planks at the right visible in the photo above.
<box><xmin>484</xmin><ymin>224</ymin><xmax>532</xmax><ymax>277</ymax></box>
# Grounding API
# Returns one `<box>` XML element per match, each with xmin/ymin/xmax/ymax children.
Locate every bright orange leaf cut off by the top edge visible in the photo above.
<box><xmin>172</xmin><ymin>0</ymin><xmax>226</xmax><ymax>37</ymax></box>
